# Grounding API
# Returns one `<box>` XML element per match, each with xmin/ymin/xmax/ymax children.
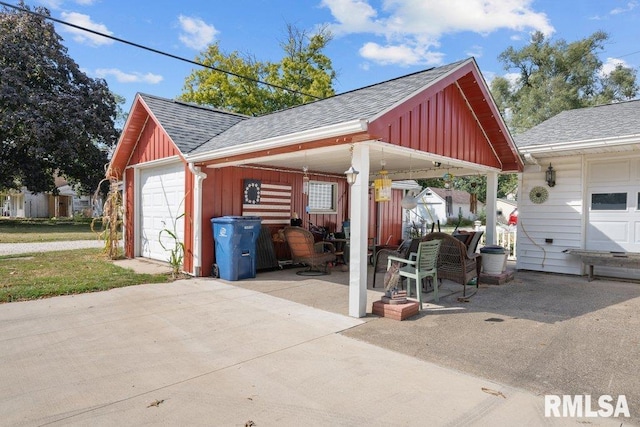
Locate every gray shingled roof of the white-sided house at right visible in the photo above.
<box><xmin>514</xmin><ymin>100</ymin><xmax>640</xmax><ymax>148</ymax></box>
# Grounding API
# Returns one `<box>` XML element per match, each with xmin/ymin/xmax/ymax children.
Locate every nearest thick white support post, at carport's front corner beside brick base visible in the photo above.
<box><xmin>349</xmin><ymin>144</ymin><xmax>369</xmax><ymax>318</ymax></box>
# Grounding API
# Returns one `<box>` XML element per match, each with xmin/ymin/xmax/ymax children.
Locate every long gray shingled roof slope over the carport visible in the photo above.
<box><xmin>192</xmin><ymin>59</ymin><xmax>469</xmax><ymax>154</ymax></box>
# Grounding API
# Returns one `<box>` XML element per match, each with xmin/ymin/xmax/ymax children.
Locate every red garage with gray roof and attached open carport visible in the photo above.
<box><xmin>107</xmin><ymin>58</ymin><xmax>523</xmax><ymax>317</ymax></box>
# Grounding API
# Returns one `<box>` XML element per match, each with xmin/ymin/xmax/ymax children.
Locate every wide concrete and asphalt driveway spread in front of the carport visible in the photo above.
<box><xmin>0</xmin><ymin>271</ymin><xmax>640</xmax><ymax>426</ymax></box>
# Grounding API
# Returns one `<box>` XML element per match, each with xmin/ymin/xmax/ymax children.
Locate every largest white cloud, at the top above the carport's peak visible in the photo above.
<box><xmin>321</xmin><ymin>0</ymin><xmax>554</xmax><ymax>65</ymax></box>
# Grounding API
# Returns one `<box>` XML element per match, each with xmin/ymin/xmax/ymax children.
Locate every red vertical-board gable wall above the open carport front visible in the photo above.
<box><xmin>369</xmin><ymin>84</ymin><xmax>502</xmax><ymax>168</ymax></box>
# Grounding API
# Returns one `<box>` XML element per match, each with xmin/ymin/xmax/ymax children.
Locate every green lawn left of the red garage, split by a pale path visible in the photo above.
<box><xmin>0</xmin><ymin>219</ymin><xmax>173</xmax><ymax>303</ymax></box>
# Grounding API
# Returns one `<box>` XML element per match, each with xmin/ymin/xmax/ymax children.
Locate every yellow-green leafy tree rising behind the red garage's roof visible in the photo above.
<box><xmin>180</xmin><ymin>25</ymin><xmax>336</xmax><ymax>116</ymax></box>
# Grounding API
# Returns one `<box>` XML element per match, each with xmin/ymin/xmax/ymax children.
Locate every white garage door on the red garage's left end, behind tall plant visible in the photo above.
<box><xmin>139</xmin><ymin>164</ymin><xmax>185</xmax><ymax>261</ymax></box>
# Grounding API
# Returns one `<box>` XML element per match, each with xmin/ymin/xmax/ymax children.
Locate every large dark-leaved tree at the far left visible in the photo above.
<box><xmin>0</xmin><ymin>2</ymin><xmax>117</xmax><ymax>192</ymax></box>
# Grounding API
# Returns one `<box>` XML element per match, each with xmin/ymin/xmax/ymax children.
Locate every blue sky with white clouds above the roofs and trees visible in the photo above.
<box><xmin>11</xmin><ymin>0</ymin><xmax>640</xmax><ymax>111</ymax></box>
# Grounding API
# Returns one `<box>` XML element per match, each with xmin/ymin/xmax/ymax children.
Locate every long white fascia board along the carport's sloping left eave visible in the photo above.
<box><xmin>185</xmin><ymin>119</ymin><xmax>367</xmax><ymax>162</ymax></box>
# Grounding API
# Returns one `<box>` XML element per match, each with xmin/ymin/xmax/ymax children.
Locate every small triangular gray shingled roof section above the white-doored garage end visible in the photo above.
<box><xmin>139</xmin><ymin>94</ymin><xmax>249</xmax><ymax>154</ymax></box>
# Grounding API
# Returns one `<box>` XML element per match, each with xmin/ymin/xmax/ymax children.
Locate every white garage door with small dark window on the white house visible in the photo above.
<box><xmin>586</xmin><ymin>158</ymin><xmax>640</xmax><ymax>252</ymax></box>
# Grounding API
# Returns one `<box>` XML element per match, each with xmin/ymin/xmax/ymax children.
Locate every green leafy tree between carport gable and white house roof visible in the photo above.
<box><xmin>491</xmin><ymin>31</ymin><xmax>639</xmax><ymax>133</ymax></box>
